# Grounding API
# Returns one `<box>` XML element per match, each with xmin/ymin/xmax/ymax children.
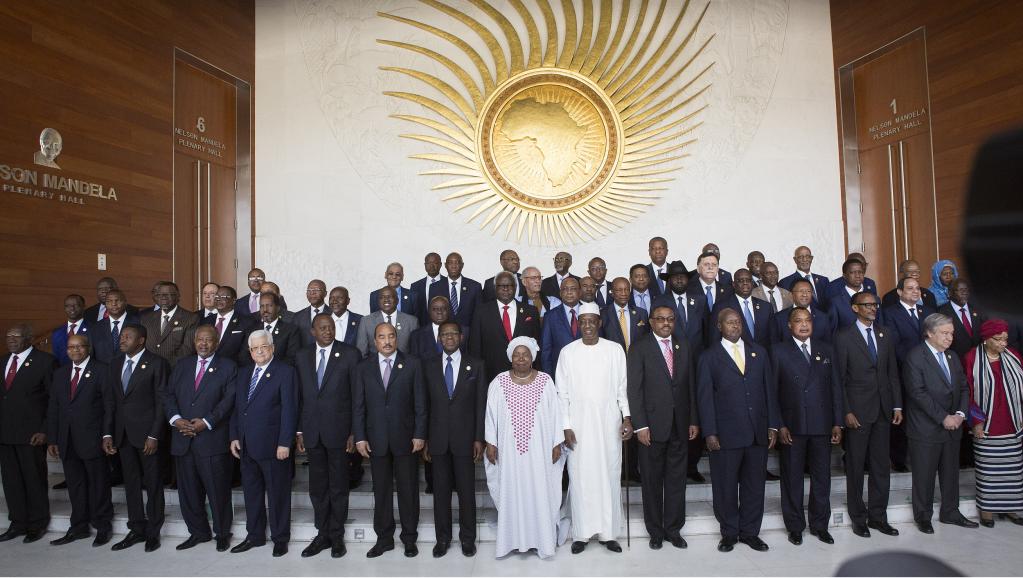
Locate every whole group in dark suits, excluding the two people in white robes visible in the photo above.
<box><xmin>0</xmin><ymin>237</ymin><xmax>1019</xmax><ymax>558</ymax></box>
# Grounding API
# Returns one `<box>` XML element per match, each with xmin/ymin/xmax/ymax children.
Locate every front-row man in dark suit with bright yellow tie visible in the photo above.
<box><xmin>697</xmin><ymin>308</ymin><xmax>781</xmax><ymax>551</ymax></box>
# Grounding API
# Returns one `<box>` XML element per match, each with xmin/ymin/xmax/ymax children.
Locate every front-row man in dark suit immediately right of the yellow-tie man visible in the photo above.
<box><xmin>770</xmin><ymin>308</ymin><xmax>845</xmax><ymax>545</ymax></box>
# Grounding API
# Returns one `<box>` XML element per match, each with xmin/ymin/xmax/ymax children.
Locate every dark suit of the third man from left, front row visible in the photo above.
<box><xmin>103</xmin><ymin>351</ymin><xmax>170</xmax><ymax>539</ymax></box>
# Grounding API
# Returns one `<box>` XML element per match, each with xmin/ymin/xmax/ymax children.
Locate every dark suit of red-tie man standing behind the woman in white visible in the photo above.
<box><xmin>469</xmin><ymin>299</ymin><xmax>540</xmax><ymax>384</ymax></box>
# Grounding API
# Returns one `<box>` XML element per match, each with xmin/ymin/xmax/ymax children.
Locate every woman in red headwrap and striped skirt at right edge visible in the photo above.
<box><xmin>964</xmin><ymin>319</ymin><xmax>1023</xmax><ymax>528</ymax></box>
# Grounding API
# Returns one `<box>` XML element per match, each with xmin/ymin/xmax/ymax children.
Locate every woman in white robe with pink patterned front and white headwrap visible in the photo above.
<box><xmin>483</xmin><ymin>337</ymin><xmax>565</xmax><ymax>558</ymax></box>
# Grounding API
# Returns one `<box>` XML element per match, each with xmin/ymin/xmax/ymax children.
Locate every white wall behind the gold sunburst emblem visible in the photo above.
<box><xmin>255</xmin><ymin>0</ymin><xmax>843</xmax><ymax>312</ymax></box>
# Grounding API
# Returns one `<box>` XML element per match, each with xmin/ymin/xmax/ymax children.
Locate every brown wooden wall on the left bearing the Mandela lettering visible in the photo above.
<box><xmin>0</xmin><ymin>0</ymin><xmax>256</xmax><ymax>334</ymax></box>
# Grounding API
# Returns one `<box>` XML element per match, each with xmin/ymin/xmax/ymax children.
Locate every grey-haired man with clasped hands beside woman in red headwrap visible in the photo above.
<box><xmin>902</xmin><ymin>313</ymin><xmax>978</xmax><ymax>534</ymax></box>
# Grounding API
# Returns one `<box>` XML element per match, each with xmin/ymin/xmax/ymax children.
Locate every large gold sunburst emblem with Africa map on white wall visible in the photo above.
<box><xmin>380</xmin><ymin>0</ymin><xmax>713</xmax><ymax>244</ymax></box>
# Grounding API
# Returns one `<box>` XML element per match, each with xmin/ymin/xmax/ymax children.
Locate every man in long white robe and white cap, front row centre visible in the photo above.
<box><xmin>554</xmin><ymin>303</ymin><xmax>632</xmax><ymax>553</ymax></box>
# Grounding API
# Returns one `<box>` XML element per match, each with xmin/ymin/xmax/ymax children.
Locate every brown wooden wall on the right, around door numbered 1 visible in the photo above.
<box><xmin>831</xmin><ymin>0</ymin><xmax>1023</xmax><ymax>278</ymax></box>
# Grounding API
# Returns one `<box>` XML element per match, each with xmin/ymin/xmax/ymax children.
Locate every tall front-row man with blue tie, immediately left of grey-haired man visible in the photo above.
<box><xmin>834</xmin><ymin>290</ymin><xmax>902</xmax><ymax>538</ymax></box>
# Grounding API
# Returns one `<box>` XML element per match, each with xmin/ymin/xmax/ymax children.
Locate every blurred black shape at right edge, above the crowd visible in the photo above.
<box><xmin>961</xmin><ymin>130</ymin><xmax>1023</xmax><ymax>325</ymax></box>
